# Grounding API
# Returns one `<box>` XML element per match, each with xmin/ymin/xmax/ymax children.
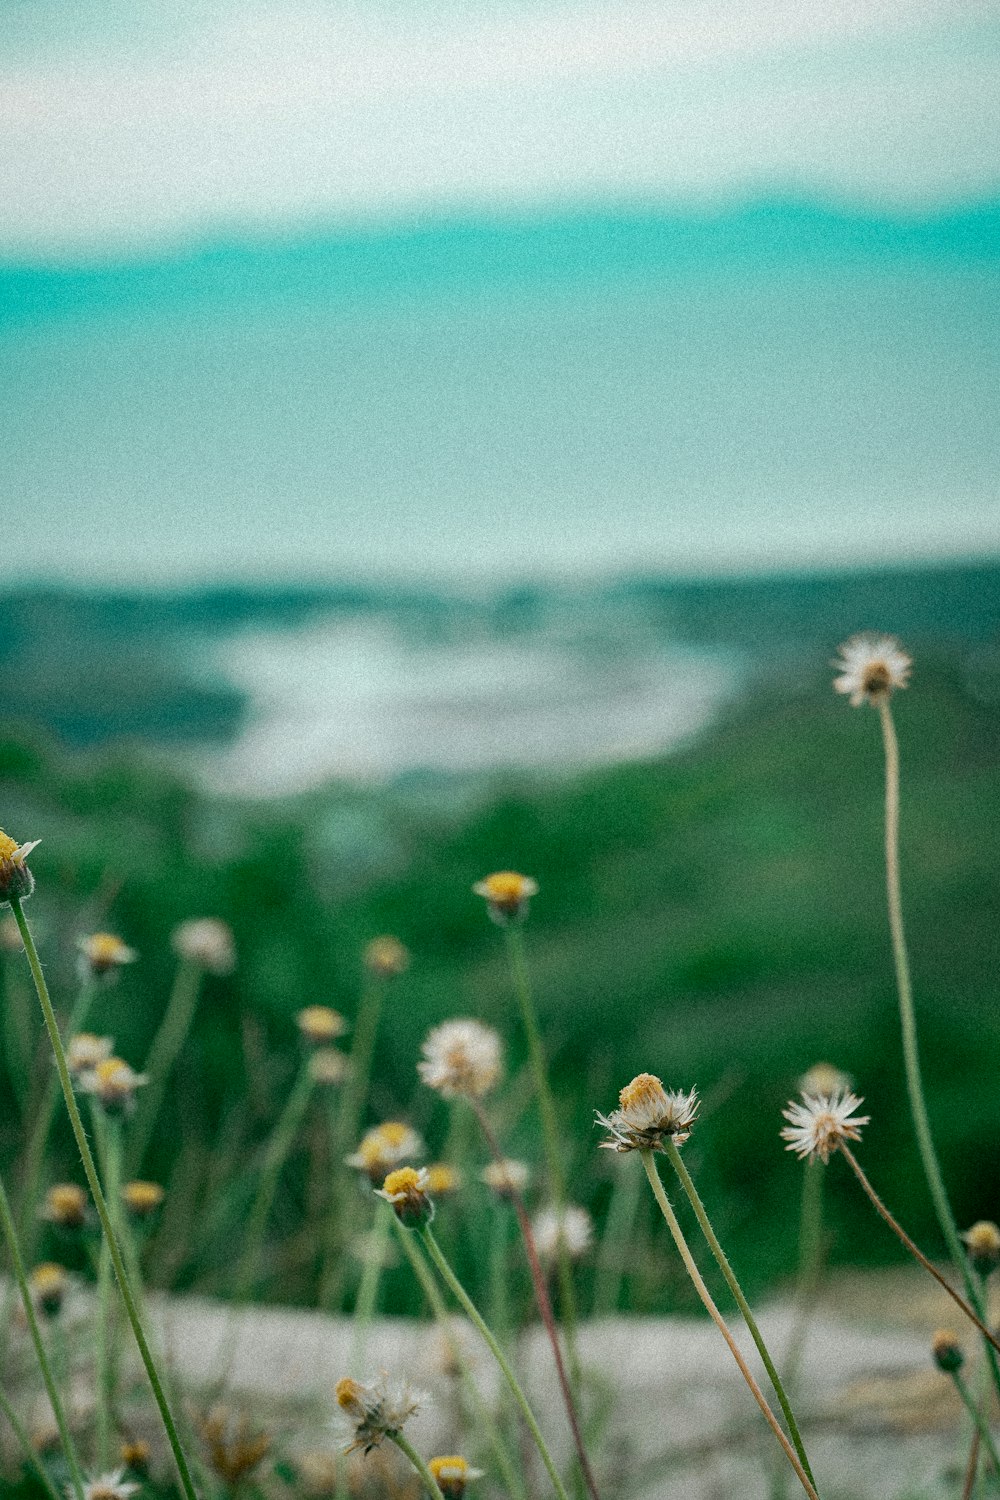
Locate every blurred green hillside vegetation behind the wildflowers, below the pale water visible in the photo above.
<box><xmin>0</xmin><ymin>648</ymin><xmax>1000</xmax><ymax>1311</ymax></box>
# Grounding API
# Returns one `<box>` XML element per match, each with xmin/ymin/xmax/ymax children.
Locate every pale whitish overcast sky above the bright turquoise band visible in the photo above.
<box><xmin>0</xmin><ymin>0</ymin><xmax>1000</xmax><ymax>260</ymax></box>
